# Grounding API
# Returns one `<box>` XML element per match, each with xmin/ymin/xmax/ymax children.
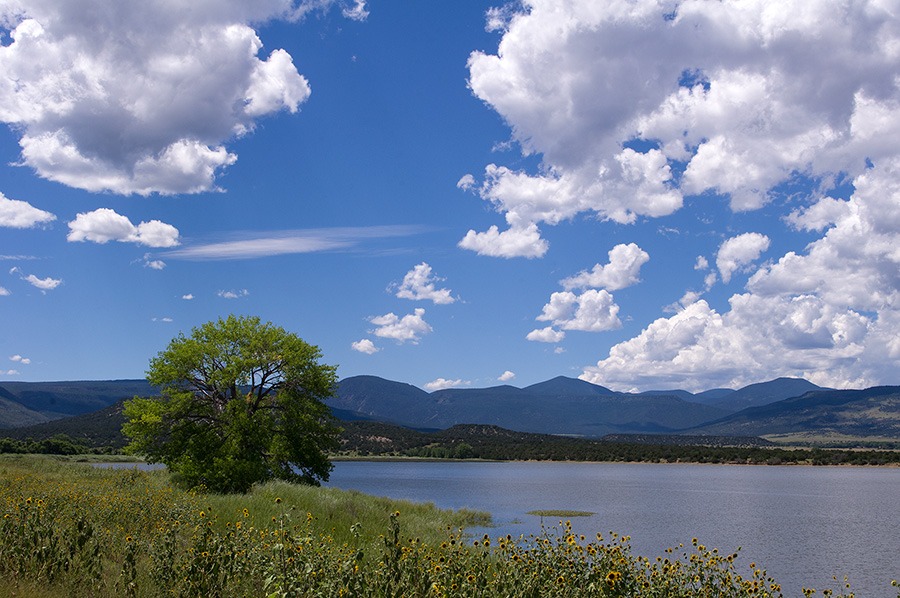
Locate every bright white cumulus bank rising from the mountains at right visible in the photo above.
<box><xmin>582</xmin><ymin>158</ymin><xmax>900</xmax><ymax>390</ymax></box>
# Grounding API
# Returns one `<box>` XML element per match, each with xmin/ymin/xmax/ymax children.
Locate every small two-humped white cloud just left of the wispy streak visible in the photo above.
<box><xmin>66</xmin><ymin>208</ymin><xmax>178</xmax><ymax>247</ymax></box>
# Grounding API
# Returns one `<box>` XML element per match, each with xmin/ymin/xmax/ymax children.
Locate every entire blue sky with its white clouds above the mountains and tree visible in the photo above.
<box><xmin>0</xmin><ymin>0</ymin><xmax>900</xmax><ymax>391</ymax></box>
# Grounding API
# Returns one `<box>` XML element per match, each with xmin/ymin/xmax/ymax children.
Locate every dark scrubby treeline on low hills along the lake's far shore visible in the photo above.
<box><xmin>341</xmin><ymin>422</ymin><xmax>900</xmax><ymax>465</ymax></box>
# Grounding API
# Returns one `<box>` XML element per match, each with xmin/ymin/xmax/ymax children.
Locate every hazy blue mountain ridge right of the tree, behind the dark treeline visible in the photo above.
<box><xmin>329</xmin><ymin>376</ymin><xmax>900</xmax><ymax>438</ymax></box>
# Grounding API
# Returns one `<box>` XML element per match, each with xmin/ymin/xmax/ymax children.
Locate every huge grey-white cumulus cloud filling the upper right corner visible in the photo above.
<box><xmin>461</xmin><ymin>0</ymin><xmax>900</xmax><ymax>257</ymax></box>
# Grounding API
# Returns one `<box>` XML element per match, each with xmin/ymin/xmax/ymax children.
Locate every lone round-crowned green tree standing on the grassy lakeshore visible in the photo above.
<box><xmin>122</xmin><ymin>315</ymin><xmax>340</xmax><ymax>492</ymax></box>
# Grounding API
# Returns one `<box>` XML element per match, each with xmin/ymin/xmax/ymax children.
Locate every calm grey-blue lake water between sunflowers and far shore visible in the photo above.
<box><xmin>326</xmin><ymin>461</ymin><xmax>900</xmax><ymax>598</ymax></box>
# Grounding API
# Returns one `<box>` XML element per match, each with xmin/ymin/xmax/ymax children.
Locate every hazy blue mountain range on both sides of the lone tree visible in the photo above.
<box><xmin>0</xmin><ymin>376</ymin><xmax>900</xmax><ymax>439</ymax></box>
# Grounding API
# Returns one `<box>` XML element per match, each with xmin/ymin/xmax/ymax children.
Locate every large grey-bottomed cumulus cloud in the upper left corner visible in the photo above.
<box><xmin>0</xmin><ymin>0</ymin><xmax>326</xmax><ymax>195</ymax></box>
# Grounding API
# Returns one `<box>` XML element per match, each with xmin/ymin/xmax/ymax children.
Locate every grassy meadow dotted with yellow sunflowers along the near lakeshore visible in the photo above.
<box><xmin>0</xmin><ymin>456</ymin><xmax>900</xmax><ymax>598</ymax></box>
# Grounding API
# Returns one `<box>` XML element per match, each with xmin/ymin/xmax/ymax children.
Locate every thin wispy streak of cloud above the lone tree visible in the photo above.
<box><xmin>165</xmin><ymin>225</ymin><xmax>430</xmax><ymax>261</ymax></box>
